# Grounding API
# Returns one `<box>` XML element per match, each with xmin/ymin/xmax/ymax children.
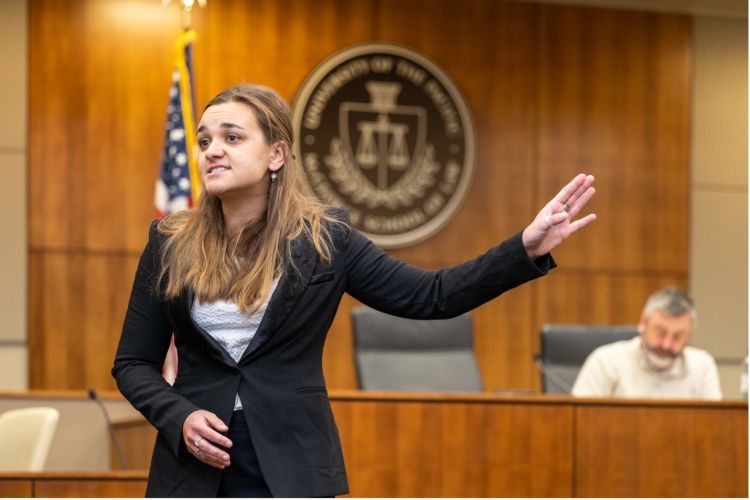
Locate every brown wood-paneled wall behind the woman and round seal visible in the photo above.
<box><xmin>29</xmin><ymin>0</ymin><xmax>692</xmax><ymax>389</ymax></box>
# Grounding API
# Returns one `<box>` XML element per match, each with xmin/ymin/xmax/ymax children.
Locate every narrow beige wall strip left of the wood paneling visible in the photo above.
<box><xmin>0</xmin><ymin>0</ymin><xmax>28</xmax><ymax>390</ymax></box>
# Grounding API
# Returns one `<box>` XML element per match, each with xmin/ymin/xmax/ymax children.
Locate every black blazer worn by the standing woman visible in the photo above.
<box><xmin>112</xmin><ymin>210</ymin><xmax>555</xmax><ymax>497</ymax></box>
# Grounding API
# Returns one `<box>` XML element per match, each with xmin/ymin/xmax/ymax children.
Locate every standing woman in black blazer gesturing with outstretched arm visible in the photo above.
<box><xmin>112</xmin><ymin>85</ymin><xmax>595</xmax><ymax>497</ymax></box>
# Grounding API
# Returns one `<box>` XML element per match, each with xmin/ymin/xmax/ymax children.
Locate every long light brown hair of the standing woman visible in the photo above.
<box><xmin>158</xmin><ymin>84</ymin><xmax>338</xmax><ymax>312</ymax></box>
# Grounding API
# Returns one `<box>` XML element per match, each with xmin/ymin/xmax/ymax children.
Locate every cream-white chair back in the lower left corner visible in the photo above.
<box><xmin>0</xmin><ymin>406</ymin><xmax>60</xmax><ymax>471</ymax></box>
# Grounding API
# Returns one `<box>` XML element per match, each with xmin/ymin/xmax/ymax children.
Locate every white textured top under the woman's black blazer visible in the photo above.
<box><xmin>190</xmin><ymin>278</ymin><xmax>279</xmax><ymax>410</ymax></box>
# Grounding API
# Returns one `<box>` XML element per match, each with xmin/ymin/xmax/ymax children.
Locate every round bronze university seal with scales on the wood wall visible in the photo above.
<box><xmin>293</xmin><ymin>43</ymin><xmax>475</xmax><ymax>248</ymax></box>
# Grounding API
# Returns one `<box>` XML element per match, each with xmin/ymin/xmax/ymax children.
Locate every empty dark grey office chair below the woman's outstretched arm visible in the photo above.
<box><xmin>352</xmin><ymin>307</ymin><xmax>482</xmax><ymax>392</ymax></box>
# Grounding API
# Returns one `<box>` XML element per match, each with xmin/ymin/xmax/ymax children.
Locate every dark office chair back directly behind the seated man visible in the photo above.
<box><xmin>535</xmin><ymin>324</ymin><xmax>638</xmax><ymax>394</ymax></box>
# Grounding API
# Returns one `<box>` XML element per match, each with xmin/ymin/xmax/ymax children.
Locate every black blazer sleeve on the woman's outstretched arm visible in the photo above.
<box><xmin>345</xmin><ymin>223</ymin><xmax>555</xmax><ymax>319</ymax></box>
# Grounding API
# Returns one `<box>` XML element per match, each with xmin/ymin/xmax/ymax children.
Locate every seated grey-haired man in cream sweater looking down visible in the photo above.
<box><xmin>571</xmin><ymin>286</ymin><xmax>721</xmax><ymax>399</ymax></box>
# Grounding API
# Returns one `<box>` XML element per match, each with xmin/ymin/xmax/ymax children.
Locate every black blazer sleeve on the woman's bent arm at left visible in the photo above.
<box><xmin>112</xmin><ymin>221</ymin><xmax>199</xmax><ymax>455</ymax></box>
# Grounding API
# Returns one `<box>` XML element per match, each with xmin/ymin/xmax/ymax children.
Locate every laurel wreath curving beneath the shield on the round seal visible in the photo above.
<box><xmin>324</xmin><ymin>137</ymin><xmax>440</xmax><ymax>210</ymax></box>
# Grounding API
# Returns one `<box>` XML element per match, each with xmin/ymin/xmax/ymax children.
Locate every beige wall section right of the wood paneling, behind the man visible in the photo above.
<box><xmin>690</xmin><ymin>17</ymin><xmax>748</xmax><ymax>397</ymax></box>
